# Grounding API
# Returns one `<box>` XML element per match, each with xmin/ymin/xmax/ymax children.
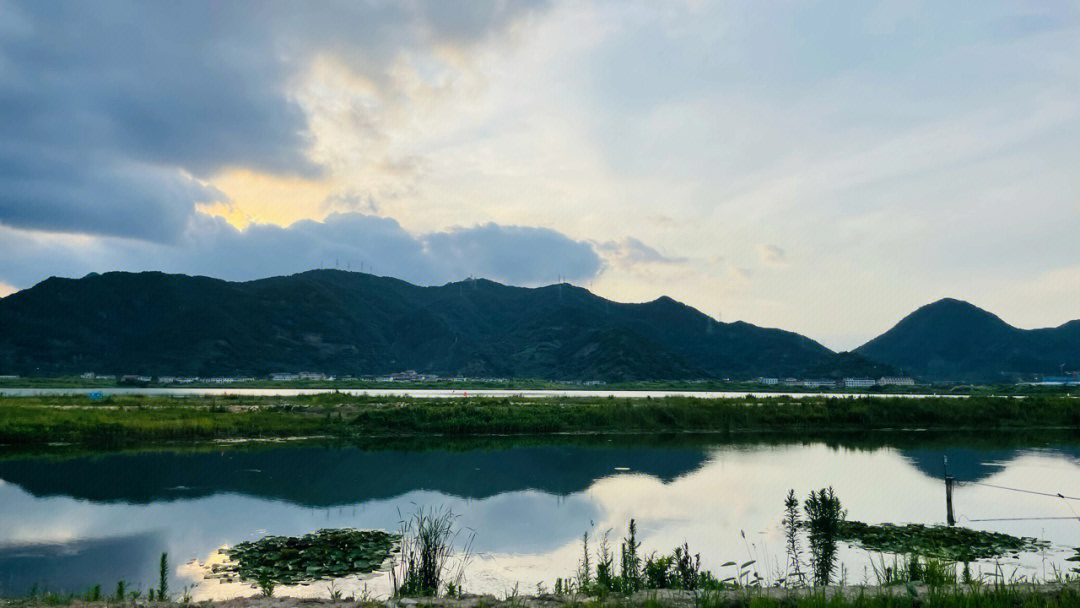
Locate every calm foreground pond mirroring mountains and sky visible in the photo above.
<box><xmin>0</xmin><ymin>432</ymin><xmax>1080</xmax><ymax>599</ymax></box>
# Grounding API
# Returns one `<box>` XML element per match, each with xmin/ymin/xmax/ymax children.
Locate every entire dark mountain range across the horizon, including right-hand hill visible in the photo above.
<box><xmin>0</xmin><ymin>270</ymin><xmax>1080</xmax><ymax>381</ymax></box>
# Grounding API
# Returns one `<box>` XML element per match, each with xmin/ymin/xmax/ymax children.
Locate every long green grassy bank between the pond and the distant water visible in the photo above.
<box><xmin>0</xmin><ymin>393</ymin><xmax>1080</xmax><ymax>445</ymax></box>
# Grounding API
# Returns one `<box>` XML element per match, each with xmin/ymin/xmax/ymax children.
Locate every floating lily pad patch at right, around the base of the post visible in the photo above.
<box><xmin>839</xmin><ymin>522</ymin><xmax>1050</xmax><ymax>562</ymax></box>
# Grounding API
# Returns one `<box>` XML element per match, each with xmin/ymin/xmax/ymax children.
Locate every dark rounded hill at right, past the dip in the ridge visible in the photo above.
<box><xmin>855</xmin><ymin>298</ymin><xmax>1080</xmax><ymax>382</ymax></box>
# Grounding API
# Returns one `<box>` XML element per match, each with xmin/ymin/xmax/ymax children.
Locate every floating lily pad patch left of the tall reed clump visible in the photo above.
<box><xmin>214</xmin><ymin>529</ymin><xmax>399</xmax><ymax>585</ymax></box>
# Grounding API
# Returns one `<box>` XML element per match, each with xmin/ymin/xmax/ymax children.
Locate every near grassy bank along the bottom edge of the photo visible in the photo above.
<box><xmin>6</xmin><ymin>583</ymin><xmax>1080</xmax><ymax>608</ymax></box>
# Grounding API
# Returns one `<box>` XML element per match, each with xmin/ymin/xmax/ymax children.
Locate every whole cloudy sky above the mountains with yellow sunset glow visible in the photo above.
<box><xmin>0</xmin><ymin>0</ymin><xmax>1080</xmax><ymax>350</ymax></box>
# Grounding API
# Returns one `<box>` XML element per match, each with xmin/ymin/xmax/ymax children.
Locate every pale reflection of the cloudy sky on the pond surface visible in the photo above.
<box><xmin>0</xmin><ymin>444</ymin><xmax>1080</xmax><ymax>598</ymax></box>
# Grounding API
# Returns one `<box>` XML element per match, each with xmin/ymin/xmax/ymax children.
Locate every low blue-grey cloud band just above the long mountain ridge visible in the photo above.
<box><xmin>0</xmin><ymin>213</ymin><xmax>603</xmax><ymax>288</ymax></box>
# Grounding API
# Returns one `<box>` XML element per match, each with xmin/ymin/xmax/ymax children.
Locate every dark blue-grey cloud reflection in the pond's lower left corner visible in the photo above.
<box><xmin>0</xmin><ymin>535</ymin><xmax>162</xmax><ymax>595</ymax></box>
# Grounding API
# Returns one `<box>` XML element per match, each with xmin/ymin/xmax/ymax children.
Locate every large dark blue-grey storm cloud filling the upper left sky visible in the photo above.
<box><xmin>0</xmin><ymin>1</ymin><xmax>552</xmax><ymax>242</ymax></box>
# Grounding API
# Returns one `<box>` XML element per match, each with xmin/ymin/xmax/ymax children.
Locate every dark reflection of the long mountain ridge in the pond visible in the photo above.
<box><xmin>0</xmin><ymin>445</ymin><xmax>708</xmax><ymax>506</ymax></box>
